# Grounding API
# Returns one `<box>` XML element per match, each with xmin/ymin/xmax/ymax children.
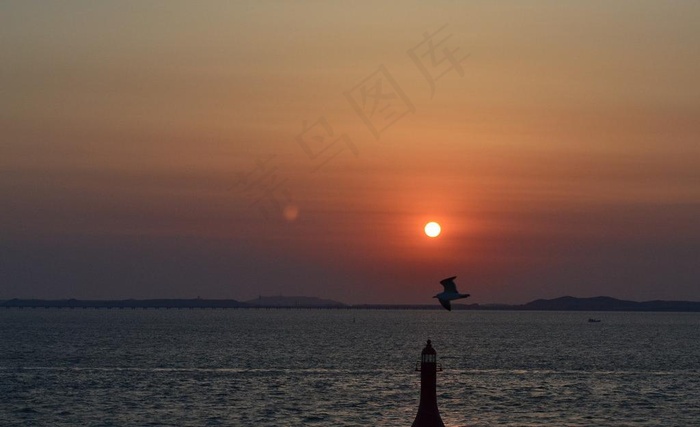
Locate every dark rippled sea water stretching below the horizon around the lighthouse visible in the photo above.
<box><xmin>0</xmin><ymin>309</ymin><xmax>700</xmax><ymax>427</ymax></box>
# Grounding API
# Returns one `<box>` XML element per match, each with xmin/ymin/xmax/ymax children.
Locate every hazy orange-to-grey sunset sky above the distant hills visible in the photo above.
<box><xmin>0</xmin><ymin>0</ymin><xmax>700</xmax><ymax>304</ymax></box>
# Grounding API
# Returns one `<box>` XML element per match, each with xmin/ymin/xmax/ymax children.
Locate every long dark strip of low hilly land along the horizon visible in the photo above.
<box><xmin>0</xmin><ymin>296</ymin><xmax>700</xmax><ymax>312</ymax></box>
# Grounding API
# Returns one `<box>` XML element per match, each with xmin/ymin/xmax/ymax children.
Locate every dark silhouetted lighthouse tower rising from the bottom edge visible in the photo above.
<box><xmin>411</xmin><ymin>340</ymin><xmax>445</xmax><ymax>427</ymax></box>
